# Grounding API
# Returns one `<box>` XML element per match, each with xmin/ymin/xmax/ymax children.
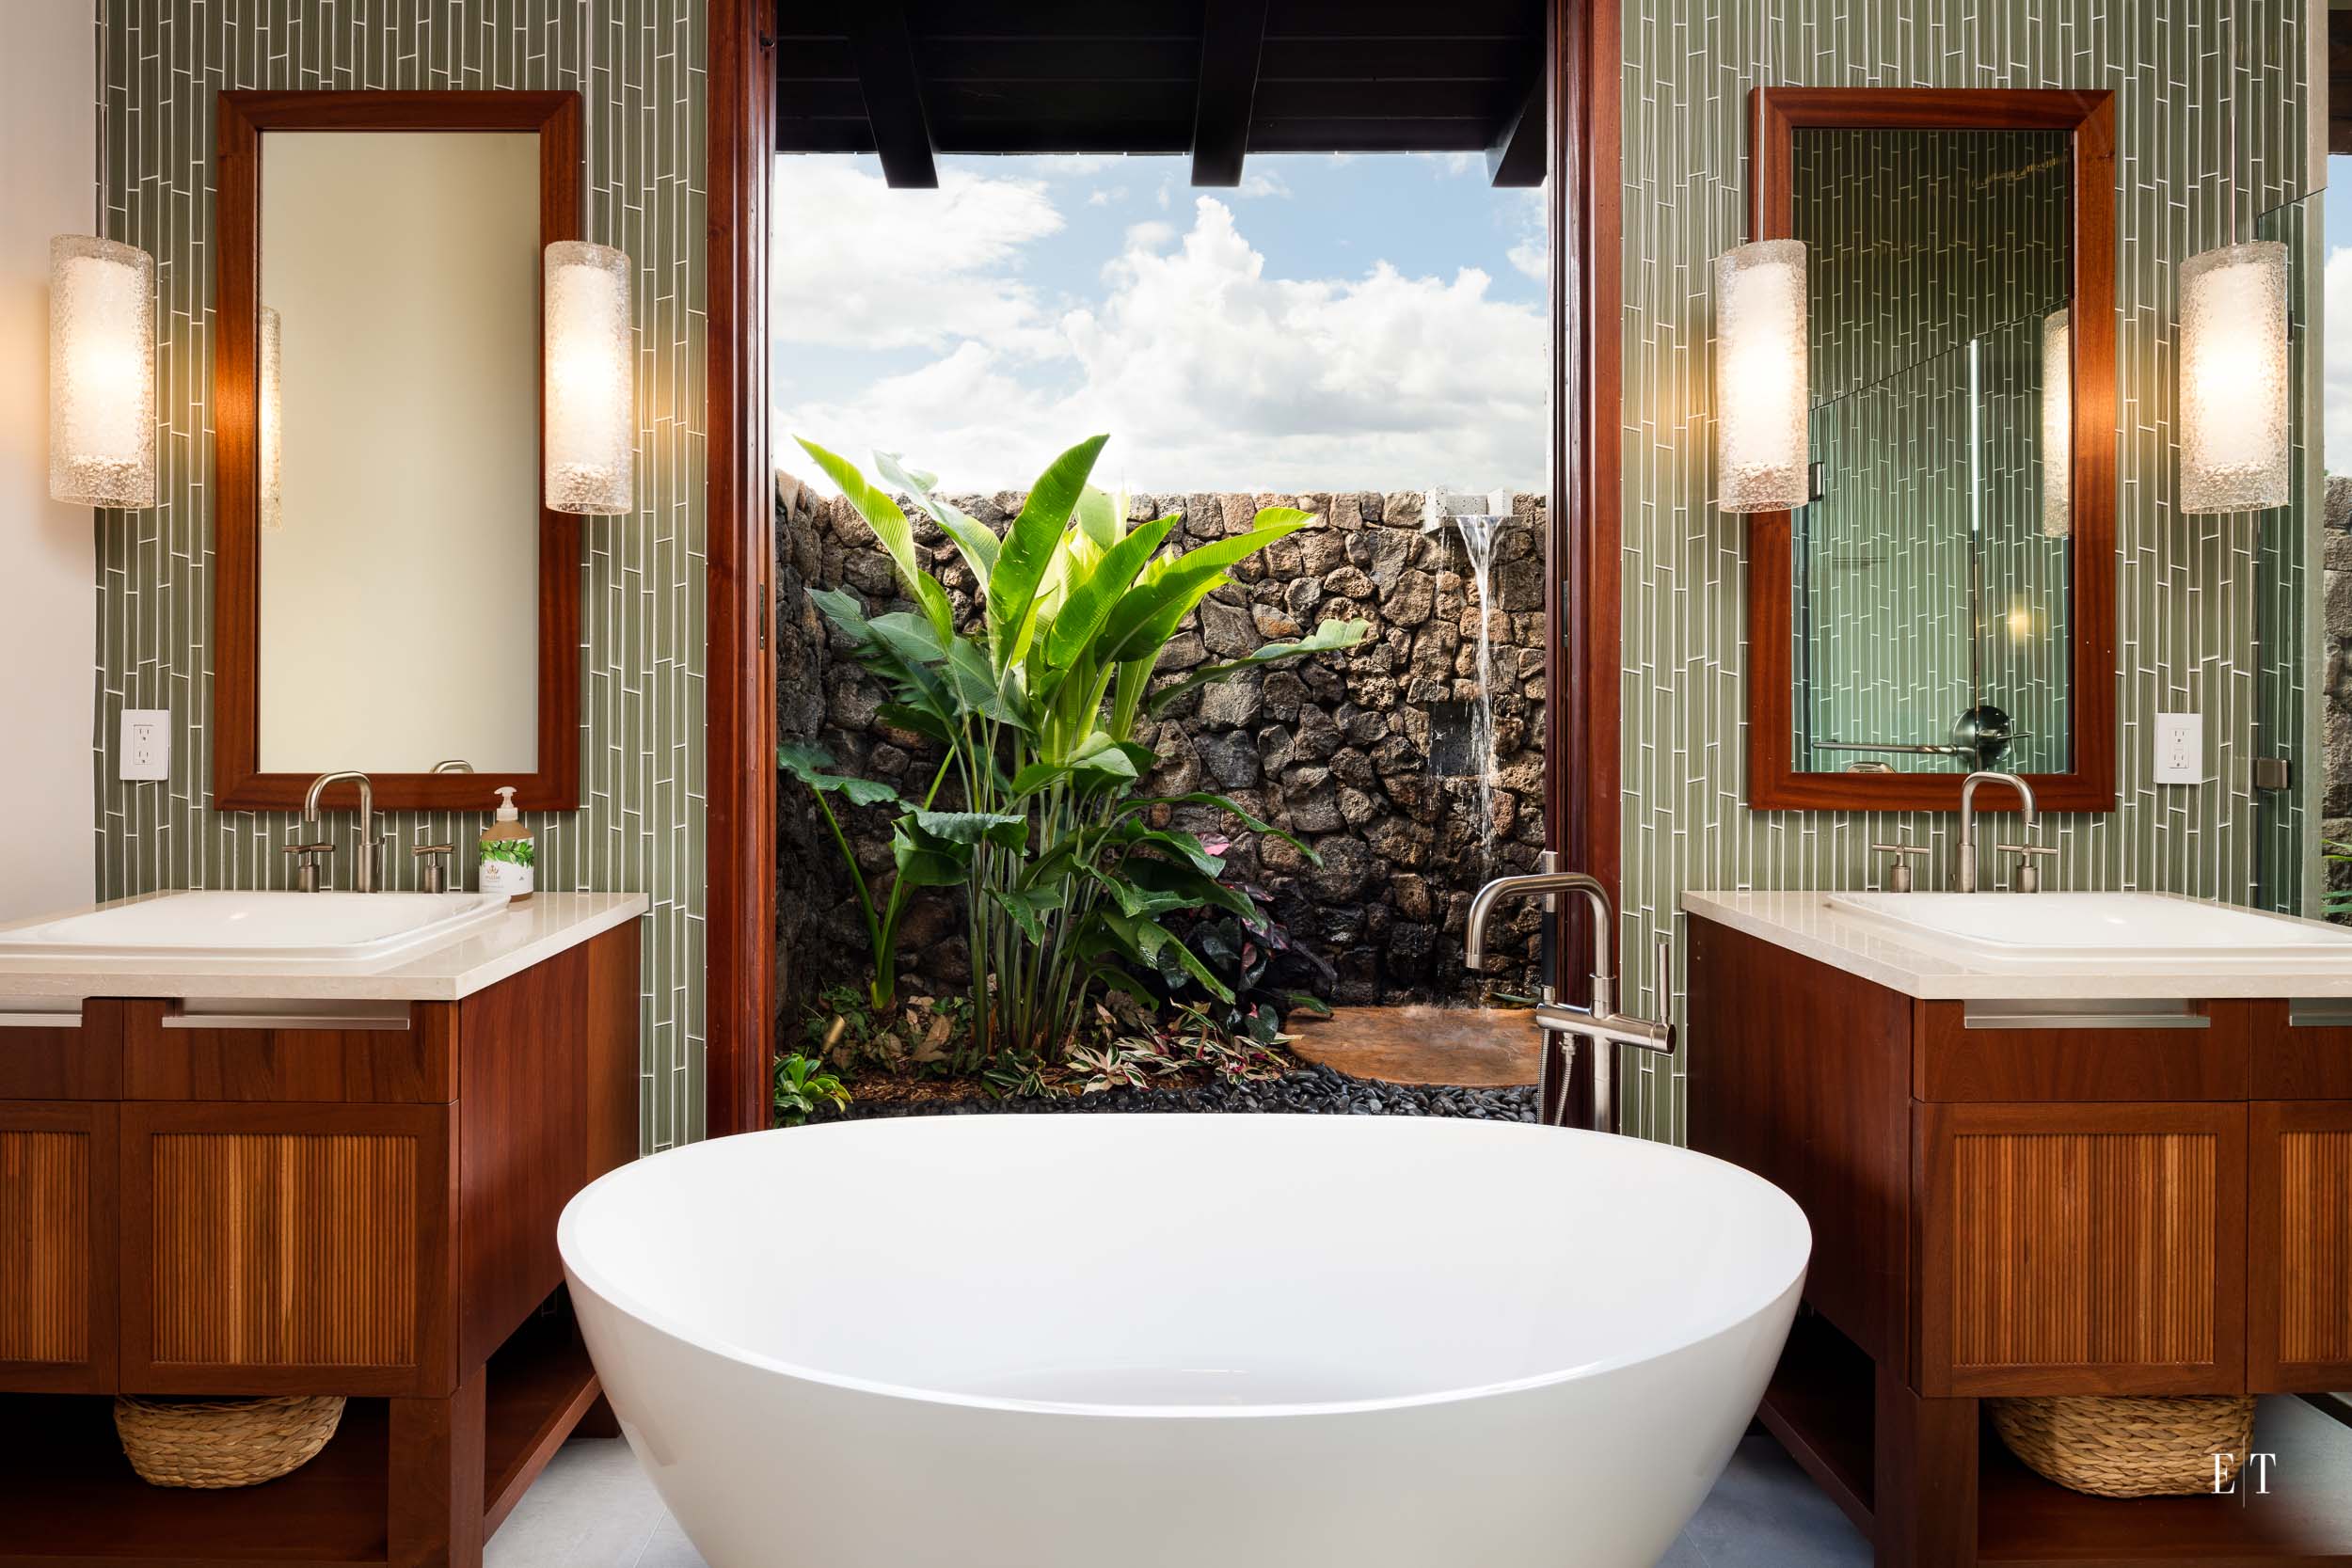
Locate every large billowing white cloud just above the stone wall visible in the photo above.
<box><xmin>779</xmin><ymin>198</ymin><xmax>1548</xmax><ymax>489</ymax></box>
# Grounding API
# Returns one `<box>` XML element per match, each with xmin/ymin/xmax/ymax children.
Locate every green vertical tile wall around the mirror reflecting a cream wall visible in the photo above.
<box><xmin>94</xmin><ymin>0</ymin><xmax>706</xmax><ymax>1149</ymax></box>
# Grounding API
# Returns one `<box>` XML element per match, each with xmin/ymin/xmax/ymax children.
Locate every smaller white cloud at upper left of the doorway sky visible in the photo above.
<box><xmin>770</xmin><ymin>157</ymin><xmax>1063</xmax><ymax>353</ymax></box>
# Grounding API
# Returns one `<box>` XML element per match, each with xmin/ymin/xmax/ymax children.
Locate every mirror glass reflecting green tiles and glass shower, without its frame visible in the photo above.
<box><xmin>1790</xmin><ymin>129</ymin><xmax>2074</xmax><ymax>773</ymax></box>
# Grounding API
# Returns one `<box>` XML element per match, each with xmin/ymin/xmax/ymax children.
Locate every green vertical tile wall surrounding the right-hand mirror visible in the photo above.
<box><xmin>1621</xmin><ymin>0</ymin><xmax>2319</xmax><ymax>1143</ymax></box>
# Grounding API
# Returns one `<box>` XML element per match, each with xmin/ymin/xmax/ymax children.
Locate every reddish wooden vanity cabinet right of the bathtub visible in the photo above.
<box><xmin>1689</xmin><ymin>917</ymin><xmax>2352</xmax><ymax>1566</ymax></box>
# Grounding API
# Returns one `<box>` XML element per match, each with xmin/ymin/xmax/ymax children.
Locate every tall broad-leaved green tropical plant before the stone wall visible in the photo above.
<box><xmin>786</xmin><ymin>435</ymin><xmax>1369</xmax><ymax>1068</ymax></box>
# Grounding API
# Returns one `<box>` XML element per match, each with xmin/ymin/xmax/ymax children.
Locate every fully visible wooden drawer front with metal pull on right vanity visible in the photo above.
<box><xmin>1913</xmin><ymin>1002</ymin><xmax>2256</xmax><ymax>1105</ymax></box>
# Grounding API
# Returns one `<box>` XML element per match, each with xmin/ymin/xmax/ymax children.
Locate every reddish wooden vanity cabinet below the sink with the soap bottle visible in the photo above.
<box><xmin>0</xmin><ymin>922</ymin><xmax>638</xmax><ymax>1566</ymax></box>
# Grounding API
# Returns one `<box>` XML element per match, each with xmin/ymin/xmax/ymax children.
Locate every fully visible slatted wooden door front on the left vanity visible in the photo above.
<box><xmin>120</xmin><ymin>1105</ymin><xmax>456</xmax><ymax>1397</ymax></box>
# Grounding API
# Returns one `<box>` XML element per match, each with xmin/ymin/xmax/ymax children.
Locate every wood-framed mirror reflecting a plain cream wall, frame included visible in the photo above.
<box><xmin>212</xmin><ymin>91</ymin><xmax>581</xmax><ymax>811</ymax></box>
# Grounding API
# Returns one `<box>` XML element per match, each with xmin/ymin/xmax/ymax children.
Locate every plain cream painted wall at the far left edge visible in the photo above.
<box><xmin>0</xmin><ymin>0</ymin><xmax>95</xmax><ymax>919</ymax></box>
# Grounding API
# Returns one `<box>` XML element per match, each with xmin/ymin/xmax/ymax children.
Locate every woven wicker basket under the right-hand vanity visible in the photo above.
<box><xmin>1990</xmin><ymin>1394</ymin><xmax>2253</xmax><ymax>1497</ymax></box>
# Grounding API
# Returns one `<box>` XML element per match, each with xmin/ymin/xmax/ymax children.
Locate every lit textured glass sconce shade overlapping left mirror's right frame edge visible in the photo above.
<box><xmin>546</xmin><ymin>240</ymin><xmax>638</xmax><ymax>515</ymax></box>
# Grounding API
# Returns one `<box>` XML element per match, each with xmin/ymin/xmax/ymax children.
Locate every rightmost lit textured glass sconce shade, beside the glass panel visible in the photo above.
<box><xmin>2181</xmin><ymin>240</ymin><xmax>2289</xmax><ymax>513</ymax></box>
